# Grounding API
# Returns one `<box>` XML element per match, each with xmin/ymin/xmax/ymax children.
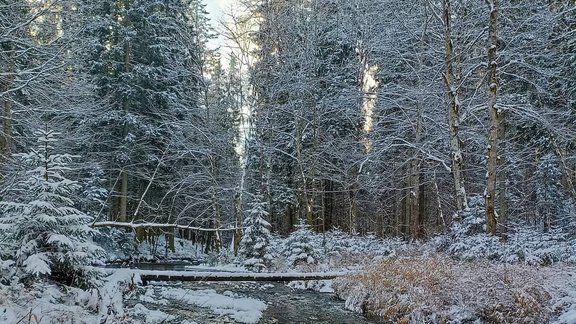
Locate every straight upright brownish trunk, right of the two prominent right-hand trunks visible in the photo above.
<box><xmin>484</xmin><ymin>0</ymin><xmax>503</xmax><ymax>234</ymax></box>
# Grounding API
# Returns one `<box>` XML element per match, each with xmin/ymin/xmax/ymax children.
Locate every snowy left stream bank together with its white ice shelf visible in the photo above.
<box><xmin>0</xmin><ymin>270</ymin><xmax>266</xmax><ymax>324</ymax></box>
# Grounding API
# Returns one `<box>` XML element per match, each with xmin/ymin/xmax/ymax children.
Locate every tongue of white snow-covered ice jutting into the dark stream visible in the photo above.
<box><xmin>161</xmin><ymin>288</ymin><xmax>266</xmax><ymax>323</ymax></box>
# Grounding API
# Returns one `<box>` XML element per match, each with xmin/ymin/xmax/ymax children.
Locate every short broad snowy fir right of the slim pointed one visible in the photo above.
<box><xmin>282</xmin><ymin>220</ymin><xmax>319</xmax><ymax>266</ymax></box>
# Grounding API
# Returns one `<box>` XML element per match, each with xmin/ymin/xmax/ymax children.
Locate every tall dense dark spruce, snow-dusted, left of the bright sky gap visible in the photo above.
<box><xmin>88</xmin><ymin>0</ymin><xmax>206</xmax><ymax>221</ymax></box>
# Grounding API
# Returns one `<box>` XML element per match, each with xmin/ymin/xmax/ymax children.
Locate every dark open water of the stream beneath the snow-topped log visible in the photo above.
<box><xmin>119</xmin><ymin>267</ymin><xmax>375</xmax><ymax>324</ymax></box>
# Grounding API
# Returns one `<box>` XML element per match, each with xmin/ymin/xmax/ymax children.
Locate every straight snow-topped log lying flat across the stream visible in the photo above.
<box><xmin>118</xmin><ymin>269</ymin><xmax>351</xmax><ymax>285</ymax></box>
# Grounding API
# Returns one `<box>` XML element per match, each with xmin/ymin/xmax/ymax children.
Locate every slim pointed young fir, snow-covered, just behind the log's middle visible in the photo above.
<box><xmin>239</xmin><ymin>196</ymin><xmax>272</xmax><ymax>272</ymax></box>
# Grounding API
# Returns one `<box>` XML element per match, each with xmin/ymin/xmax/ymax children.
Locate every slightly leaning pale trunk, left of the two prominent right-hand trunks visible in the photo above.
<box><xmin>442</xmin><ymin>0</ymin><xmax>468</xmax><ymax>217</ymax></box>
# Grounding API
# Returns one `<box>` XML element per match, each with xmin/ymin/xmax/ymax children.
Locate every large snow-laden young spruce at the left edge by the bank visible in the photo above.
<box><xmin>0</xmin><ymin>130</ymin><xmax>101</xmax><ymax>286</ymax></box>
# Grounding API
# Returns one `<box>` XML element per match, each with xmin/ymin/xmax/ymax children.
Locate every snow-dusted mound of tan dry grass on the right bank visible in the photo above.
<box><xmin>336</xmin><ymin>255</ymin><xmax>551</xmax><ymax>323</ymax></box>
